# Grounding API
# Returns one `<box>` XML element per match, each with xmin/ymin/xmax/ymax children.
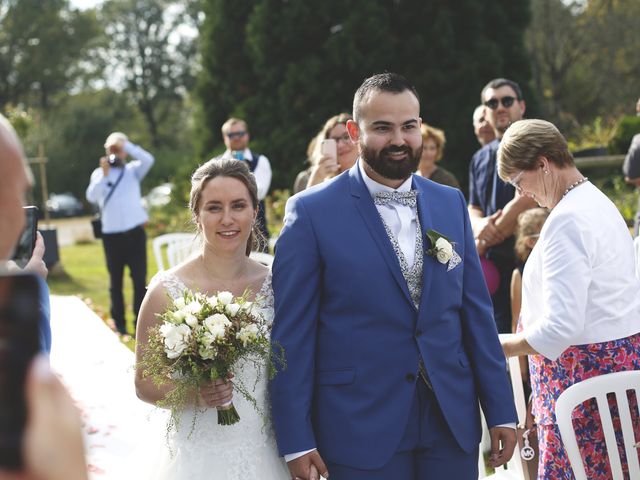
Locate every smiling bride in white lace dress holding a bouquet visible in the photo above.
<box><xmin>135</xmin><ymin>159</ymin><xmax>290</xmax><ymax>480</ymax></box>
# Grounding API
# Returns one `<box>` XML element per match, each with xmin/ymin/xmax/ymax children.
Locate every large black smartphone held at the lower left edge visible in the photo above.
<box><xmin>0</xmin><ymin>273</ymin><xmax>40</xmax><ymax>470</ymax></box>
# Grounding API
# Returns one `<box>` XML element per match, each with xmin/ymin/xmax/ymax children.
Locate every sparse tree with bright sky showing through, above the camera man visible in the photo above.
<box><xmin>102</xmin><ymin>0</ymin><xmax>197</xmax><ymax>147</ymax></box>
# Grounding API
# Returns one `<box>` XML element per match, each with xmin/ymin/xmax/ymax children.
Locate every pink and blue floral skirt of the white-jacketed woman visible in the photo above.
<box><xmin>529</xmin><ymin>334</ymin><xmax>640</xmax><ymax>480</ymax></box>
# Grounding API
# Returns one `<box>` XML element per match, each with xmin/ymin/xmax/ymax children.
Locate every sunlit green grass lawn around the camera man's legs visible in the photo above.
<box><xmin>47</xmin><ymin>241</ymin><xmax>157</xmax><ymax>347</ymax></box>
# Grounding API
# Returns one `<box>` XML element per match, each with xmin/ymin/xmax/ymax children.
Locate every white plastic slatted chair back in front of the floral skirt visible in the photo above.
<box><xmin>556</xmin><ymin>370</ymin><xmax>640</xmax><ymax>480</ymax></box>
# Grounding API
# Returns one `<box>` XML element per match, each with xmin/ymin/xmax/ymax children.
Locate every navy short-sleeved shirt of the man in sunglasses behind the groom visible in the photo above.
<box><xmin>469</xmin><ymin>139</ymin><xmax>516</xmax><ymax>217</ymax></box>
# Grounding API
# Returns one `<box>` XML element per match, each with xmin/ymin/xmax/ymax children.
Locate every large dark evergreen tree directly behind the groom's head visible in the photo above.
<box><xmin>198</xmin><ymin>0</ymin><xmax>530</xmax><ymax>188</ymax></box>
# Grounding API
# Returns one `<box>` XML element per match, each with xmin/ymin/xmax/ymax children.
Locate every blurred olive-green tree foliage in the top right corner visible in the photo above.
<box><xmin>527</xmin><ymin>0</ymin><xmax>640</xmax><ymax>135</ymax></box>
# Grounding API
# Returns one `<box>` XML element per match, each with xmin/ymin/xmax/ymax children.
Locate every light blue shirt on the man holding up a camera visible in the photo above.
<box><xmin>86</xmin><ymin>142</ymin><xmax>154</xmax><ymax>234</ymax></box>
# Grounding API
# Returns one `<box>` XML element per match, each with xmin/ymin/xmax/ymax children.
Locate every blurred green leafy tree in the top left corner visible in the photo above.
<box><xmin>0</xmin><ymin>0</ymin><xmax>100</xmax><ymax>110</ymax></box>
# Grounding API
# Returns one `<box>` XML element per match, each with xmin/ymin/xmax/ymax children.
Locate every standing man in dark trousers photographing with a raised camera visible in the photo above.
<box><xmin>86</xmin><ymin>132</ymin><xmax>154</xmax><ymax>335</ymax></box>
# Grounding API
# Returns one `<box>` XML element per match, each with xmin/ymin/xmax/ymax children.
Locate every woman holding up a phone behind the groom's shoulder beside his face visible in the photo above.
<box><xmin>293</xmin><ymin>113</ymin><xmax>358</xmax><ymax>193</ymax></box>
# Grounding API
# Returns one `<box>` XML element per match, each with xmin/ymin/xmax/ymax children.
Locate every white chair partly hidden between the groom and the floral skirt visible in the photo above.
<box><xmin>478</xmin><ymin>334</ymin><xmax>532</xmax><ymax>480</ymax></box>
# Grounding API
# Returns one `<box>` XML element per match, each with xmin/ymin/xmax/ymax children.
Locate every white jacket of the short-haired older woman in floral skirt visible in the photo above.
<box><xmin>521</xmin><ymin>182</ymin><xmax>640</xmax><ymax>360</ymax></box>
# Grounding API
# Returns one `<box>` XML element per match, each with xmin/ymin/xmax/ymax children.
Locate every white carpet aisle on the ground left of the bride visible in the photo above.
<box><xmin>51</xmin><ymin>296</ymin><xmax>164</xmax><ymax>480</ymax></box>
